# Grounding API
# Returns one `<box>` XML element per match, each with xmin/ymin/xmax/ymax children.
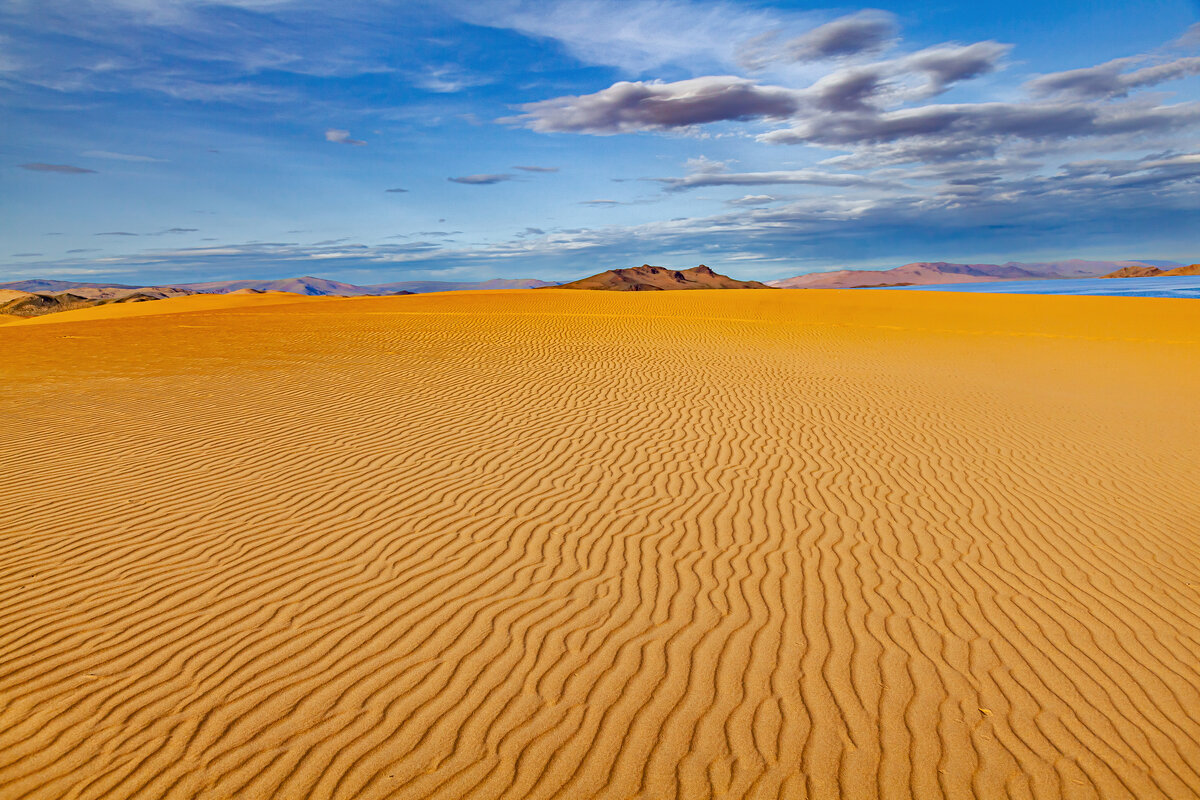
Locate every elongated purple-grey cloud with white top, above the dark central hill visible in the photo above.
<box><xmin>502</xmin><ymin>76</ymin><xmax>803</xmax><ymax>134</ymax></box>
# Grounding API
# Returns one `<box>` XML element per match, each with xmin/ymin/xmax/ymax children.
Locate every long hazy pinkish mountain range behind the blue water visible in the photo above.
<box><xmin>767</xmin><ymin>259</ymin><xmax>1171</xmax><ymax>289</ymax></box>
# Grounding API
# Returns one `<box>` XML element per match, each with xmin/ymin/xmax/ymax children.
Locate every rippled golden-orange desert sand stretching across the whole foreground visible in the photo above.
<box><xmin>0</xmin><ymin>289</ymin><xmax>1200</xmax><ymax>800</ymax></box>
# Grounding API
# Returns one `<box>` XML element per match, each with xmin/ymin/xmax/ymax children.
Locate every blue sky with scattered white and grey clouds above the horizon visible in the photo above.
<box><xmin>0</xmin><ymin>0</ymin><xmax>1200</xmax><ymax>283</ymax></box>
